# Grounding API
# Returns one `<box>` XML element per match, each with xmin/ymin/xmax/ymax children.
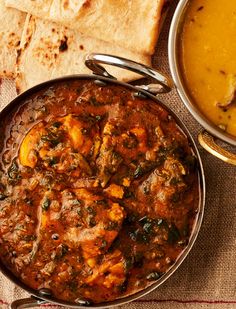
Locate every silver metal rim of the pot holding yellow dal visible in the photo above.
<box><xmin>168</xmin><ymin>0</ymin><xmax>236</xmax><ymax>146</ymax></box>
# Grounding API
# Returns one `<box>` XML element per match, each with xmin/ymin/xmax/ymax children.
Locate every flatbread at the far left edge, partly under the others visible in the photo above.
<box><xmin>0</xmin><ymin>0</ymin><xmax>26</xmax><ymax>78</ymax></box>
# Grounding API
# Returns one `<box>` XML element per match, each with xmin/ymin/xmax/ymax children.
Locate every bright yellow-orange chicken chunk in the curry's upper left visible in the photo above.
<box><xmin>19</xmin><ymin>114</ymin><xmax>100</xmax><ymax>176</ymax></box>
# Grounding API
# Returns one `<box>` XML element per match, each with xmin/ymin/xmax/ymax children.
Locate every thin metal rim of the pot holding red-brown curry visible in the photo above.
<box><xmin>0</xmin><ymin>74</ymin><xmax>206</xmax><ymax>309</ymax></box>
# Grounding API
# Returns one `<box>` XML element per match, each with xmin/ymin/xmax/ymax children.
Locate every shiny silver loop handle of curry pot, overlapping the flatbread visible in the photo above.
<box><xmin>85</xmin><ymin>53</ymin><xmax>173</xmax><ymax>94</ymax></box>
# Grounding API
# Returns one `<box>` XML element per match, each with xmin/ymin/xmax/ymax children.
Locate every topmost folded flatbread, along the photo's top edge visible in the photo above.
<box><xmin>5</xmin><ymin>0</ymin><xmax>165</xmax><ymax>55</ymax></box>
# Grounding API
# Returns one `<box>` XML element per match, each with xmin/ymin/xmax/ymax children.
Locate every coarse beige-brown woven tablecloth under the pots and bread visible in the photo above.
<box><xmin>0</xmin><ymin>1</ymin><xmax>236</xmax><ymax>309</ymax></box>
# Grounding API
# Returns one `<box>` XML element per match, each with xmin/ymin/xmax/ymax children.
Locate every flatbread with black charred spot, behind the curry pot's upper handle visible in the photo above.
<box><xmin>16</xmin><ymin>15</ymin><xmax>151</xmax><ymax>92</ymax></box>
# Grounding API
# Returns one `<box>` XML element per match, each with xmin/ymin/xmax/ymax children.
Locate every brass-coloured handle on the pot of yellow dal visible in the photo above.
<box><xmin>198</xmin><ymin>131</ymin><xmax>236</xmax><ymax>165</ymax></box>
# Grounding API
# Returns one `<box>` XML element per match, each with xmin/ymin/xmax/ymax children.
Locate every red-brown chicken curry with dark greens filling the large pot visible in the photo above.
<box><xmin>0</xmin><ymin>80</ymin><xmax>200</xmax><ymax>303</ymax></box>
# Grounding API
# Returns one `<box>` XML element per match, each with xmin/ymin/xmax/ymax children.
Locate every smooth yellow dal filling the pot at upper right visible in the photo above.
<box><xmin>180</xmin><ymin>0</ymin><xmax>236</xmax><ymax>136</ymax></box>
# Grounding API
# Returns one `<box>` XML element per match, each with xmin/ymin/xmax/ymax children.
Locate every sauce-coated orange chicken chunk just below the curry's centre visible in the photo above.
<box><xmin>64</xmin><ymin>189</ymin><xmax>125</xmax><ymax>259</ymax></box>
